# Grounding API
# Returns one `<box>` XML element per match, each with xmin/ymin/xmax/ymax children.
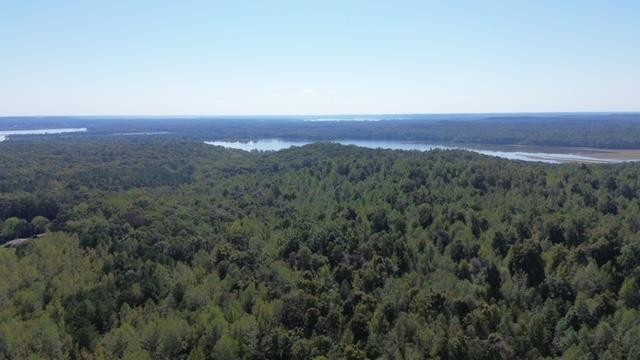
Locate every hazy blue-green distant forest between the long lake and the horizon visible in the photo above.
<box><xmin>0</xmin><ymin>113</ymin><xmax>640</xmax><ymax>149</ymax></box>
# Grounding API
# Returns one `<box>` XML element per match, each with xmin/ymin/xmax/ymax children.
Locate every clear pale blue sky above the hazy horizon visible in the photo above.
<box><xmin>0</xmin><ymin>0</ymin><xmax>640</xmax><ymax>115</ymax></box>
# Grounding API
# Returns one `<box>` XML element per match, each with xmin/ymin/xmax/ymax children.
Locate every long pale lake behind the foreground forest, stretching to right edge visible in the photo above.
<box><xmin>205</xmin><ymin>139</ymin><xmax>640</xmax><ymax>164</ymax></box>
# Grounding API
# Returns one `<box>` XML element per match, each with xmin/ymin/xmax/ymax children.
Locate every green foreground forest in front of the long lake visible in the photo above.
<box><xmin>0</xmin><ymin>138</ymin><xmax>640</xmax><ymax>359</ymax></box>
